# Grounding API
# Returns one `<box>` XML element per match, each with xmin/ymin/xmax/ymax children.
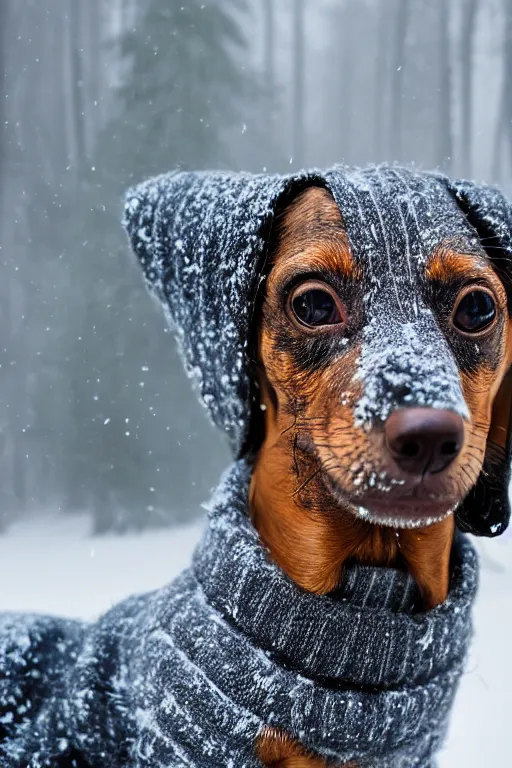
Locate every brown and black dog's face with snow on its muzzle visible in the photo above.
<box><xmin>259</xmin><ymin>187</ymin><xmax>511</xmax><ymax>527</ymax></box>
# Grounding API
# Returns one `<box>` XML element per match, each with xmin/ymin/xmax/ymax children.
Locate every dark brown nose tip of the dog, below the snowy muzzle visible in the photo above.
<box><xmin>384</xmin><ymin>408</ymin><xmax>464</xmax><ymax>475</ymax></box>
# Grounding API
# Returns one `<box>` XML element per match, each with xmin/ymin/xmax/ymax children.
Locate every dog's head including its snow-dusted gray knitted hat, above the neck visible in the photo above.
<box><xmin>125</xmin><ymin>167</ymin><xmax>512</xmax><ymax>535</ymax></box>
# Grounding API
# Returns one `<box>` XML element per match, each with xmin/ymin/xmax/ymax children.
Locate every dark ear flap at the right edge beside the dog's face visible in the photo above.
<box><xmin>452</xmin><ymin>181</ymin><xmax>512</xmax><ymax>536</ymax></box>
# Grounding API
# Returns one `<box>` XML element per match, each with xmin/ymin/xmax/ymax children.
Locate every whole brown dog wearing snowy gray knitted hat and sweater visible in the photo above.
<box><xmin>0</xmin><ymin>166</ymin><xmax>512</xmax><ymax>768</ymax></box>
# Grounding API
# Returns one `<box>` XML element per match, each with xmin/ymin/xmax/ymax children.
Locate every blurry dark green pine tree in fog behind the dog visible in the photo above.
<box><xmin>58</xmin><ymin>0</ymin><xmax>258</xmax><ymax>531</ymax></box>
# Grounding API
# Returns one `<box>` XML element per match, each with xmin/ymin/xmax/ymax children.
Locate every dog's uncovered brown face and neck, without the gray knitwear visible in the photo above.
<box><xmin>250</xmin><ymin>187</ymin><xmax>512</xmax><ymax>768</ymax></box>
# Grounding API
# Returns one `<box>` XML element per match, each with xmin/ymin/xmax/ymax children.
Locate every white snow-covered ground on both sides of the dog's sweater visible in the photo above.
<box><xmin>0</xmin><ymin>517</ymin><xmax>512</xmax><ymax>768</ymax></box>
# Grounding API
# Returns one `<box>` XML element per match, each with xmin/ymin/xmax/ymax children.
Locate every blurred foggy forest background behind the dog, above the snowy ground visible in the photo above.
<box><xmin>0</xmin><ymin>0</ymin><xmax>512</xmax><ymax>532</ymax></box>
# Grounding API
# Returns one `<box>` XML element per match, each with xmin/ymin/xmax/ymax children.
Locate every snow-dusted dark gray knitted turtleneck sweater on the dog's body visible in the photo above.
<box><xmin>0</xmin><ymin>461</ymin><xmax>477</xmax><ymax>768</ymax></box>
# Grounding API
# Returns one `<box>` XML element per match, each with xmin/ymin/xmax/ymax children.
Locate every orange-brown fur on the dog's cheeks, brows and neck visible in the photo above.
<box><xmin>250</xmin><ymin>188</ymin><xmax>511</xmax><ymax>768</ymax></box>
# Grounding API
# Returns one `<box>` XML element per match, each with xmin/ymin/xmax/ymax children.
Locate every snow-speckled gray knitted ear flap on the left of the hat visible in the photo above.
<box><xmin>124</xmin><ymin>168</ymin><xmax>322</xmax><ymax>455</ymax></box>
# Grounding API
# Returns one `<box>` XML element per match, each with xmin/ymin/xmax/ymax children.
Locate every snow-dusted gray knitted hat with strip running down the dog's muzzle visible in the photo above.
<box><xmin>124</xmin><ymin>166</ymin><xmax>512</xmax><ymax>536</ymax></box>
